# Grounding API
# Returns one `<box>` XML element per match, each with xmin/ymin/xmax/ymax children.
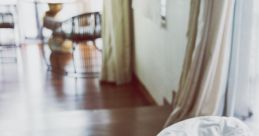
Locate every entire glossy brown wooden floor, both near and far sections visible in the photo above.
<box><xmin>0</xmin><ymin>45</ymin><xmax>173</xmax><ymax>136</ymax></box>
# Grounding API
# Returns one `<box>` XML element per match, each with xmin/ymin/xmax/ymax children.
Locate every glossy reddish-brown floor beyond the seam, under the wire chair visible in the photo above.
<box><xmin>0</xmin><ymin>45</ymin><xmax>150</xmax><ymax>112</ymax></box>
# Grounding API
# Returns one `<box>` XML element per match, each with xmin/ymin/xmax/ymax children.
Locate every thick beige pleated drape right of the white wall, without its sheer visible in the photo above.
<box><xmin>166</xmin><ymin>0</ymin><xmax>235</xmax><ymax>125</ymax></box>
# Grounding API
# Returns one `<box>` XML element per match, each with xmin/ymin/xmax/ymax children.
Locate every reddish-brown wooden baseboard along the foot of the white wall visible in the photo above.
<box><xmin>132</xmin><ymin>75</ymin><xmax>159</xmax><ymax>106</ymax></box>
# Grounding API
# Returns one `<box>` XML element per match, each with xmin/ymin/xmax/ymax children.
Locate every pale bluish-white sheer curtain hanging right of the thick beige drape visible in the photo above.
<box><xmin>229</xmin><ymin>0</ymin><xmax>254</xmax><ymax>119</ymax></box>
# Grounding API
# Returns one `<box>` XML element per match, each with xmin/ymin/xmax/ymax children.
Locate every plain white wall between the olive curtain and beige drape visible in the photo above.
<box><xmin>133</xmin><ymin>0</ymin><xmax>190</xmax><ymax>104</ymax></box>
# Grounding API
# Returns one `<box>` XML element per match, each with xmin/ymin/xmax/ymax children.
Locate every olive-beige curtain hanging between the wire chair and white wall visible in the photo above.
<box><xmin>101</xmin><ymin>0</ymin><xmax>132</xmax><ymax>84</ymax></box>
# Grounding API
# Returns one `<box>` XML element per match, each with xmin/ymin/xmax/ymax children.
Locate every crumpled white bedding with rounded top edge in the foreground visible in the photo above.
<box><xmin>158</xmin><ymin>116</ymin><xmax>253</xmax><ymax>136</ymax></box>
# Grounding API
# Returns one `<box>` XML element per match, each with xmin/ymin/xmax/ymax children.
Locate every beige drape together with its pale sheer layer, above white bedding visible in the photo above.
<box><xmin>166</xmin><ymin>0</ymin><xmax>255</xmax><ymax>126</ymax></box>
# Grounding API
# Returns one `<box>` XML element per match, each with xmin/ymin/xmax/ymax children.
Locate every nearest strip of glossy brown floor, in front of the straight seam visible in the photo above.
<box><xmin>0</xmin><ymin>107</ymin><xmax>173</xmax><ymax>136</ymax></box>
